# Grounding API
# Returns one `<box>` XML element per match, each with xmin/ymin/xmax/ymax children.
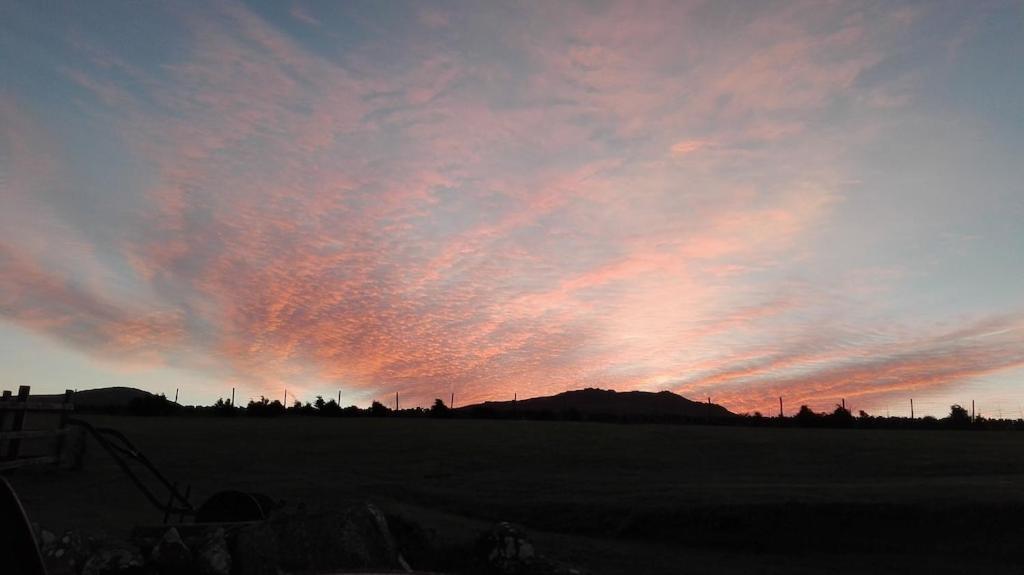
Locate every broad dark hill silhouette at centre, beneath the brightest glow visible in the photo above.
<box><xmin>456</xmin><ymin>388</ymin><xmax>736</xmax><ymax>417</ymax></box>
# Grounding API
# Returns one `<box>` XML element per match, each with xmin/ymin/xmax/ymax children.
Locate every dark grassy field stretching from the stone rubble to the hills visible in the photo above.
<box><xmin>10</xmin><ymin>416</ymin><xmax>1024</xmax><ymax>573</ymax></box>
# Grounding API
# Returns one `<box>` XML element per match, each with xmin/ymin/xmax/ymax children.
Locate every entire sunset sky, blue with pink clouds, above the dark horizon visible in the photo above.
<box><xmin>0</xmin><ymin>0</ymin><xmax>1024</xmax><ymax>411</ymax></box>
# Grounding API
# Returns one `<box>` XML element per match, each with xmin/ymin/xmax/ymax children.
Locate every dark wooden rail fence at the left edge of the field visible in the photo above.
<box><xmin>0</xmin><ymin>386</ymin><xmax>75</xmax><ymax>471</ymax></box>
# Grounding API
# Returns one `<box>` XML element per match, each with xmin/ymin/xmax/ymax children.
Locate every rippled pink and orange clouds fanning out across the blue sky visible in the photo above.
<box><xmin>0</xmin><ymin>3</ymin><xmax>1024</xmax><ymax>409</ymax></box>
